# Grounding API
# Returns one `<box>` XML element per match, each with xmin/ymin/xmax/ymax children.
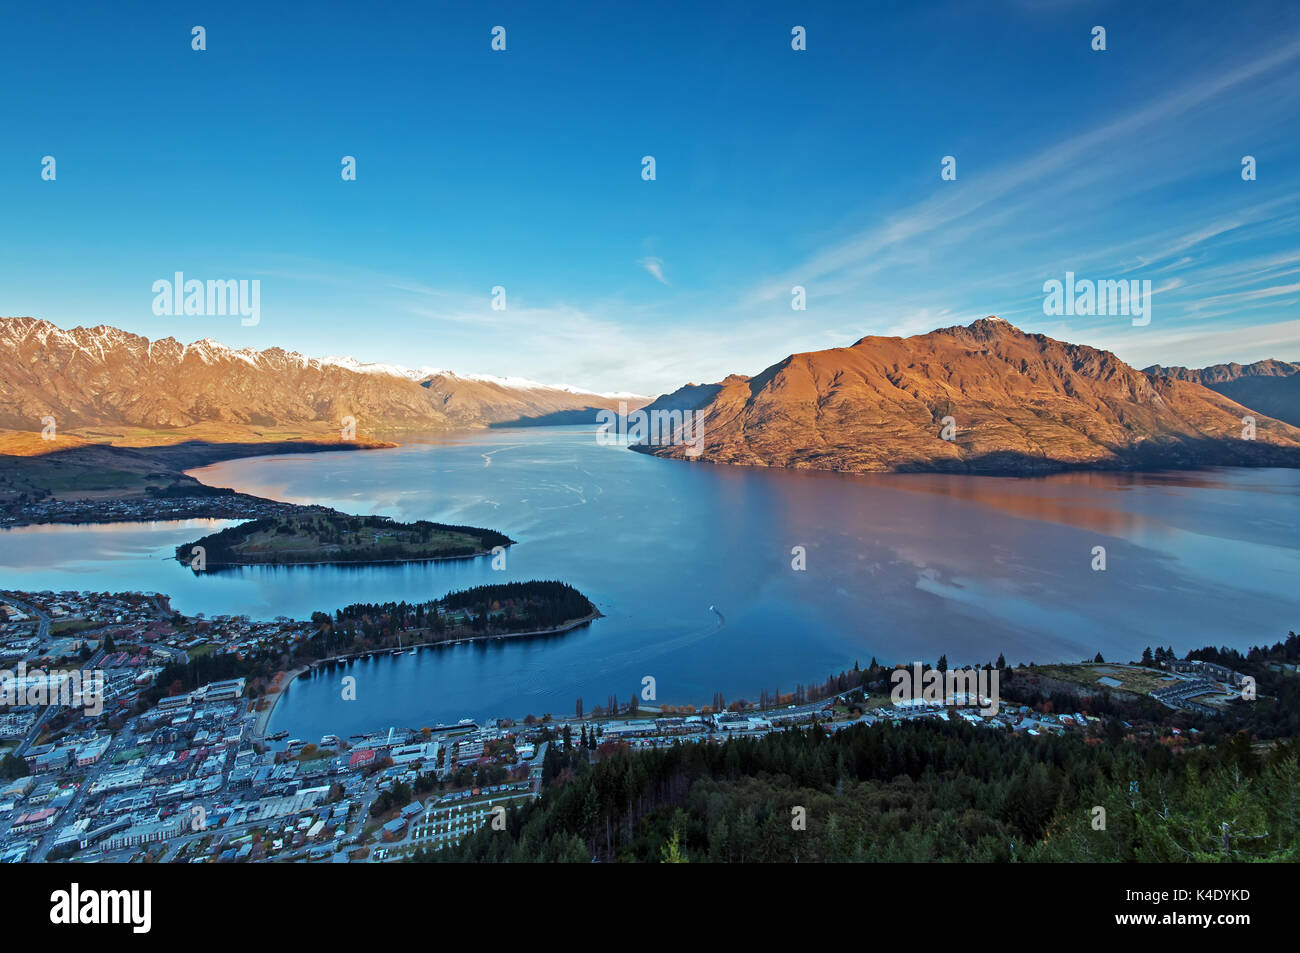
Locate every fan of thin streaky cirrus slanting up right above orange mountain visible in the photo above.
<box><xmin>742</xmin><ymin>35</ymin><xmax>1300</xmax><ymax>356</ymax></box>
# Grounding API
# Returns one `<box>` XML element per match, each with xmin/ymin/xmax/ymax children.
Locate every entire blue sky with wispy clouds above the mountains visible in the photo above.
<box><xmin>0</xmin><ymin>0</ymin><xmax>1300</xmax><ymax>393</ymax></box>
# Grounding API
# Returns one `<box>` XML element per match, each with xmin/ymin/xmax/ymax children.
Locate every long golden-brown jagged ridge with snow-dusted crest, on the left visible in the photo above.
<box><xmin>0</xmin><ymin>317</ymin><xmax>645</xmax><ymax>433</ymax></box>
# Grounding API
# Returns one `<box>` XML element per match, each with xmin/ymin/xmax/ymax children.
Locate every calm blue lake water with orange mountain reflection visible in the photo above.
<box><xmin>0</xmin><ymin>428</ymin><xmax>1300</xmax><ymax>740</ymax></box>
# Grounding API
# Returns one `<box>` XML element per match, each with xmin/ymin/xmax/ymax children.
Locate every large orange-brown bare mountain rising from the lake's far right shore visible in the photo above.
<box><xmin>641</xmin><ymin>317</ymin><xmax>1300</xmax><ymax>473</ymax></box>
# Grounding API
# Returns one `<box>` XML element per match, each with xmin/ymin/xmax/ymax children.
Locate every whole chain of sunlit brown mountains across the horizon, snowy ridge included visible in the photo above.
<box><xmin>0</xmin><ymin>317</ymin><xmax>1300</xmax><ymax>473</ymax></box>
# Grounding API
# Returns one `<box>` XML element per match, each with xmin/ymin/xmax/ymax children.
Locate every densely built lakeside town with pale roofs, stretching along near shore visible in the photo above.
<box><xmin>0</xmin><ymin>592</ymin><xmax>1279</xmax><ymax>863</ymax></box>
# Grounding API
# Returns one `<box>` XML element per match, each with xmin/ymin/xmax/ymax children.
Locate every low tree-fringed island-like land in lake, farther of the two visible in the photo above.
<box><xmin>176</xmin><ymin>510</ymin><xmax>514</xmax><ymax>572</ymax></box>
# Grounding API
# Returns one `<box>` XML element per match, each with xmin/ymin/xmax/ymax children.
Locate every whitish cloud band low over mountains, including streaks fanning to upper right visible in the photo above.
<box><xmin>175</xmin><ymin>31</ymin><xmax>1300</xmax><ymax>394</ymax></box>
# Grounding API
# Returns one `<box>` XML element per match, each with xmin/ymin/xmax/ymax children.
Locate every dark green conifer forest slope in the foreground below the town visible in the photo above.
<box><xmin>420</xmin><ymin>722</ymin><xmax>1300</xmax><ymax>862</ymax></box>
